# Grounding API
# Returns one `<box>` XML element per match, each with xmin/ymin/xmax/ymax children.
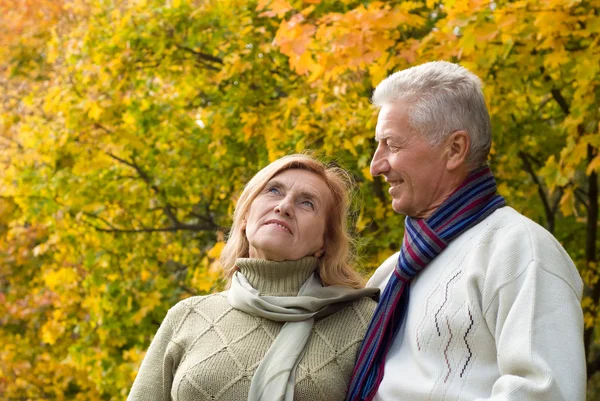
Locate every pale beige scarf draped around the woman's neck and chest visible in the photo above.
<box><xmin>227</xmin><ymin>258</ymin><xmax>379</xmax><ymax>401</ymax></box>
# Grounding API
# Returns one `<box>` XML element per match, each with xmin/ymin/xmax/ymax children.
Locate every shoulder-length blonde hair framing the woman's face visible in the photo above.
<box><xmin>221</xmin><ymin>154</ymin><xmax>362</xmax><ymax>288</ymax></box>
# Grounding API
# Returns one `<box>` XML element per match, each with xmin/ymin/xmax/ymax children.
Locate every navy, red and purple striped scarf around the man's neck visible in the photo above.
<box><xmin>346</xmin><ymin>166</ymin><xmax>505</xmax><ymax>401</ymax></box>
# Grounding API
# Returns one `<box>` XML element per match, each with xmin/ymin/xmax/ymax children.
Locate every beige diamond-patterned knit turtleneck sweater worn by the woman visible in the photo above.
<box><xmin>128</xmin><ymin>258</ymin><xmax>376</xmax><ymax>401</ymax></box>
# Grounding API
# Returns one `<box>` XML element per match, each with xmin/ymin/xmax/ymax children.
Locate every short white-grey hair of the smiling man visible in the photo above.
<box><xmin>373</xmin><ymin>61</ymin><xmax>492</xmax><ymax>168</ymax></box>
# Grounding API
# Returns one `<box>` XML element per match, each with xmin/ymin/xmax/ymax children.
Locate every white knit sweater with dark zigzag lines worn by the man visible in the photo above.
<box><xmin>367</xmin><ymin>207</ymin><xmax>586</xmax><ymax>401</ymax></box>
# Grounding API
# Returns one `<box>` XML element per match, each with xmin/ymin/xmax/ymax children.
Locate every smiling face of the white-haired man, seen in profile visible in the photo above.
<box><xmin>371</xmin><ymin>101</ymin><xmax>454</xmax><ymax>218</ymax></box>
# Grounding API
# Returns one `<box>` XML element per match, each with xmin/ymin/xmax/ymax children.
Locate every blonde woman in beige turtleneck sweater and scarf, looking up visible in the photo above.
<box><xmin>128</xmin><ymin>155</ymin><xmax>377</xmax><ymax>401</ymax></box>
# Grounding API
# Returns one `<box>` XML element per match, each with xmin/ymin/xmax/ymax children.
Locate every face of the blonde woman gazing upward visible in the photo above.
<box><xmin>243</xmin><ymin>169</ymin><xmax>332</xmax><ymax>261</ymax></box>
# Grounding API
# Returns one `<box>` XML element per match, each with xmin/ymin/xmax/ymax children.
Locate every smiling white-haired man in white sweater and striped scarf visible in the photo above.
<box><xmin>347</xmin><ymin>62</ymin><xmax>586</xmax><ymax>401</ymax></box>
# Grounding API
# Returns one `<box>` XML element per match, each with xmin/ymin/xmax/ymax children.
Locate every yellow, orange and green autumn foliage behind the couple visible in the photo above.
<box><xmin>0</xmin><ymin>0</ymin><xmax>600</xmax><ymax>400</ymax></box>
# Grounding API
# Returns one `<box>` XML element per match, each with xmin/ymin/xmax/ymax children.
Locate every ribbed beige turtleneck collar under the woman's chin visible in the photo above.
<box><xmin>235</xmin><ymin>256</ymin><xmax>319</xmax><ymax>296</ymax></box>
